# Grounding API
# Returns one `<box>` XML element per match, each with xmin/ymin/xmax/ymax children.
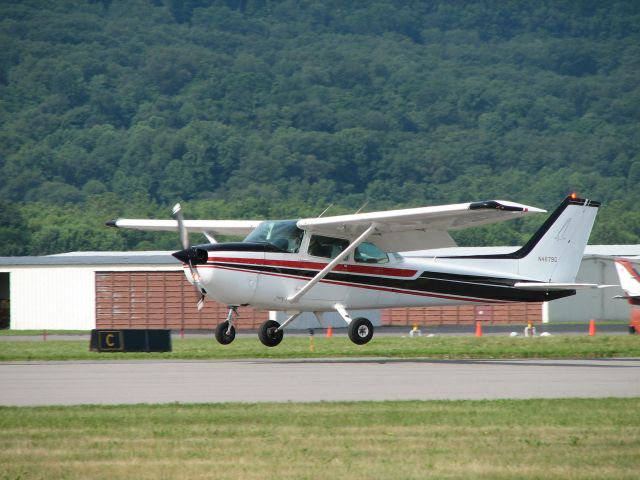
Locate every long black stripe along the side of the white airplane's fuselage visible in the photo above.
<box><xmin>208</xmin><ymin>262</ymin><xmax>576</xmax><ymax>302</ymax></box>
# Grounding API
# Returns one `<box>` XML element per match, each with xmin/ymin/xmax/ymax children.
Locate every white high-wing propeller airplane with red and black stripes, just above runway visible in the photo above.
<box><xmin>107</xmin><ymin>194</ymin><xmax>600</xmax><ymax>347</ymax></box>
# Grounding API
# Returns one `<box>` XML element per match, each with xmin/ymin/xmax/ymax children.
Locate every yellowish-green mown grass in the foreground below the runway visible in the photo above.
<box><xmin>0</xmin><ymin>398</ymin><xmax>640</xmax><ymax>480</ymax></box>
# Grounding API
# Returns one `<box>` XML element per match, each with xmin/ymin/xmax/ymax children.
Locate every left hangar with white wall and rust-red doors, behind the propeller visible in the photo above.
<box><xmin>0</xmin><ymin>252</ymin><xmax>268</xmax><ymax>330</ymax></box>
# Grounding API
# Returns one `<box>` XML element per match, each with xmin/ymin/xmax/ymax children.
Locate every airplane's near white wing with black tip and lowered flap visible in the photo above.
<box><xmin>298</xmin><ymin>200</ymin><xmax>546</xmax><ymax>252</ymax></box>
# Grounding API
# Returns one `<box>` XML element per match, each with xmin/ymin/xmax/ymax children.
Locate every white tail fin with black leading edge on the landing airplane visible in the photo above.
<box><xmin>511</xmin><ymin>195</ymin><xmax>600</xmax><ymax>283</ymax></box>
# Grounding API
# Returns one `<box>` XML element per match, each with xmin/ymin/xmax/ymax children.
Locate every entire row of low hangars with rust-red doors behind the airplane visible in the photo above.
<box><xmin>0</xmin><ymin>245</ymin><xmax>640</xmax><ymax>330</ymax></box>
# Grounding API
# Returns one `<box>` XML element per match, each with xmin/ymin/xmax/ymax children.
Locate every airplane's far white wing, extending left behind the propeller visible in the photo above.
<box><xmin>106</xmin><ymin>218</ymin><xmax>262</xmax><ymax>242</ymax></box>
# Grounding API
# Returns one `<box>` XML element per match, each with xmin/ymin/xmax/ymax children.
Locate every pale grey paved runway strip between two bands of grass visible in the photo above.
<box><xmin>0</xmin><ymin>359</ymin><xmax>640</xmax><ymax>406</ymax></box>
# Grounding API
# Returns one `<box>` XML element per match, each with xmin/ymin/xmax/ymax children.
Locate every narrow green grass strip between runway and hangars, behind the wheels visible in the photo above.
<box><xmin>0</xmin><ymin>335</ymin><xmax>640</xmax><ymax>361</ymax></box>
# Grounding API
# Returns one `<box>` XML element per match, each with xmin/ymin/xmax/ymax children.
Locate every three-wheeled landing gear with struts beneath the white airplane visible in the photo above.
<box><xmin>216</xmin><ymin>305</ymin><xmax>373</xmax><ymax>347</ymax></box>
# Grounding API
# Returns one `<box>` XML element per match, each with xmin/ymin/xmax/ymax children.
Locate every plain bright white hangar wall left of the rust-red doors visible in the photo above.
<box><xmin>11</xmin><ymin>267</ymin><xmax>96</xmax><ymax>330</ymax></box>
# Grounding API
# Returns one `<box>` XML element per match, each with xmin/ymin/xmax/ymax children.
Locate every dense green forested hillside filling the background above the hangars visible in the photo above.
<box><xmin>0</xmin><ymin>0</ymin><xmax>640</xmax><ymax>255</ymax></box>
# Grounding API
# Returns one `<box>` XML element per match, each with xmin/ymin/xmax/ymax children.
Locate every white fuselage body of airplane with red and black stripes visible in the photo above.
<box><xmin>185</xmin><ymin>242</ymin><xmax>575</xmax><ymax>311</ymax></box>
